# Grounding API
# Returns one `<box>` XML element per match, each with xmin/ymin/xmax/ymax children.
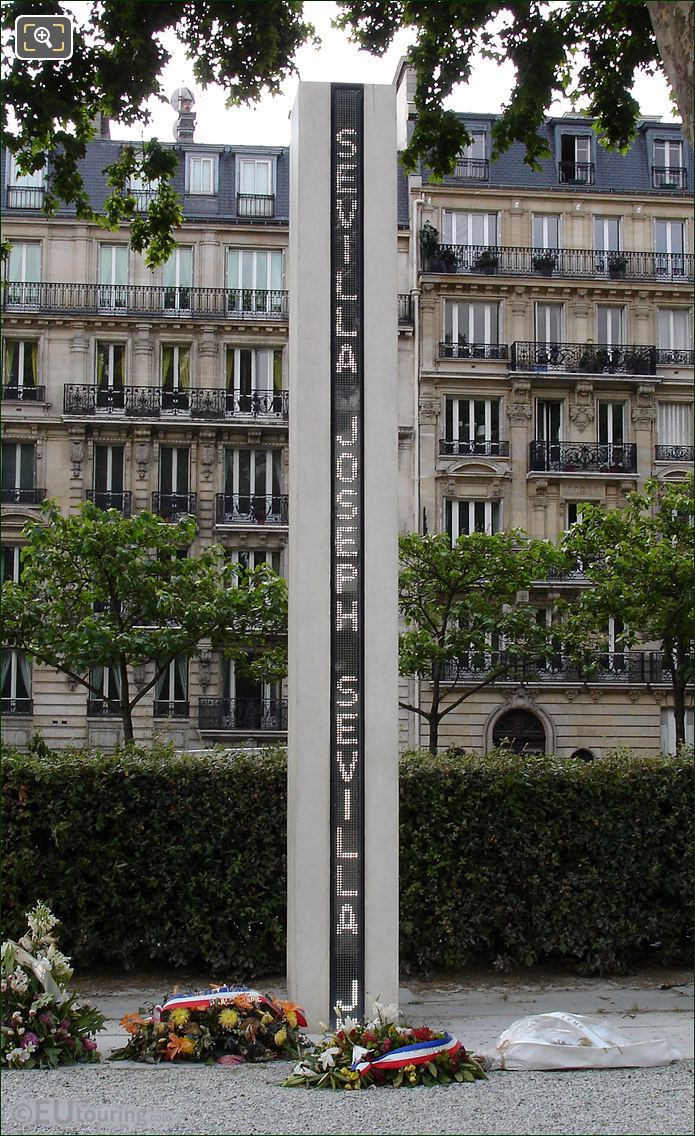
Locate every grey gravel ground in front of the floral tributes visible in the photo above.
<box><xmin>2</xmin><ymin>1061</ymin><xmax>693</xmax><ymax>1136</ymax></box>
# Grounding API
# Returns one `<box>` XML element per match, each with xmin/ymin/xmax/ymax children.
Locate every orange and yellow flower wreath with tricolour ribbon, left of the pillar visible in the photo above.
<box><xmin>111</xmin><ymin>986</ymin><xmax>307</xmax><ymax>1064</ymax></box>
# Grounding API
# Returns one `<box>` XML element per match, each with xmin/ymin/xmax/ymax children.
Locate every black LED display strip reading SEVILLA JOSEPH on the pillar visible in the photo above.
<box><xmin>330</xmin><ymin>84</ymin><xmax>365</xmax><ymax>1018</ymax></box>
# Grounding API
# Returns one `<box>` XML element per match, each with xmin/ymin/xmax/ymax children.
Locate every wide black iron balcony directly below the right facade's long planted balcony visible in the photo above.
<box><xmin>510</xmin><ymin>341</ymin><xmax>656</xmax><ymax>375</ymax></box>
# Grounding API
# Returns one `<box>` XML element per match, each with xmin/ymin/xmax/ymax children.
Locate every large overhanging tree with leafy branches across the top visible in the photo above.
<box><xmin>2</xmin><ymin>0</ymin><xmax>694</xmax><ymax>266</ymax></box>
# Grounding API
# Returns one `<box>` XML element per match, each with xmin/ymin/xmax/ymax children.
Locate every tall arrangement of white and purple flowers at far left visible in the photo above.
<box><xmin>0</xmin><ymin>903</ymin><xmax>103</xmax><ymax>1069</ymax></box>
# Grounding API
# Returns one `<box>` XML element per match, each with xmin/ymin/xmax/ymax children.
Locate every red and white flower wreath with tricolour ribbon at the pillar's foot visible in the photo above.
<box><xmin>284</xmin><ymin>1002</ymin><xmax>486</xmax><ymax>1089</ymax></box>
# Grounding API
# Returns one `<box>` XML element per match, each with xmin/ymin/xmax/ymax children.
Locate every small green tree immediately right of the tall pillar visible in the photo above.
<box><xmin>399</xmin><ymin>529</ymin><xmax>556</xmax><ymax>753</ymax></box>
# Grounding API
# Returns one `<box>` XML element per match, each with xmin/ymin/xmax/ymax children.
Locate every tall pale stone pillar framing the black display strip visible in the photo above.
<box><xmin>287</xmin><ymin>83</ymin><xmax>399</xmax><ymax>1028</ymax></box>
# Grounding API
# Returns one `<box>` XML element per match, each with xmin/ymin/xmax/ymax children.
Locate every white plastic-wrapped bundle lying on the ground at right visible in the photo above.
<box><xmin>489</xmin><ymin>1010</ymin><xmax>680</xmax><ymax>1070</ymax></box>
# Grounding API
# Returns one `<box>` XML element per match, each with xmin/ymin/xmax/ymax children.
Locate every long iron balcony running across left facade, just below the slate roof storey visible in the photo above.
<box><xmin>2</xmin><ymin>282</ymin><xmax>287</xmax><ymax>321</ymax></box>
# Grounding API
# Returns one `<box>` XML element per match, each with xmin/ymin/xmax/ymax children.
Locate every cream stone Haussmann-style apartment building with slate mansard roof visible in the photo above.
<box><xmin>1</xmin><ymin>73</ymin><xmax>694</xmax><ymax>758</ymax></box>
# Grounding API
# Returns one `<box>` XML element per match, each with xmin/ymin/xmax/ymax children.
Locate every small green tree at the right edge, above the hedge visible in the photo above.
<box><xmin>562</xmin><ymin>478</ymin><xmax>695</xmax><ymax>746</ymax></box>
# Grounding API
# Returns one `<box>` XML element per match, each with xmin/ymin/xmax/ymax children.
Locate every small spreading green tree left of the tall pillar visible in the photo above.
<box><xmin>0</xmin><ymin>502</ymin><xmax>286</xmax><ymax>742</ymax></box>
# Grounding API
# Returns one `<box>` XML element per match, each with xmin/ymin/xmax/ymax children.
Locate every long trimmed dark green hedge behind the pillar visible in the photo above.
<box><xmin>3</xmin><ymin>746</ymin><xmax>693</xmax><ymax>978</ymax></box>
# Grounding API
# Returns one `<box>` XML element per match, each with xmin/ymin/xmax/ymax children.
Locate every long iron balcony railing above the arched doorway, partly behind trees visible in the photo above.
<box><xmin>443</xmin><ymin>651</ymin><xmax>671</xmax><ymax>683</ymax></box>
